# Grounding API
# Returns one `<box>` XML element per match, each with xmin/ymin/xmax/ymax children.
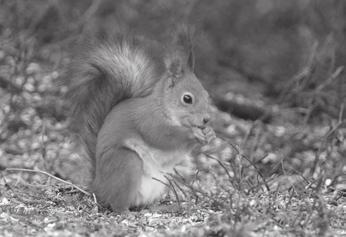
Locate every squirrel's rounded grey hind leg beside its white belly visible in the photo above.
<box><xmin>91</xmin><ymin>147</ymin><xmax>143</xmax><ymax>212</ymax></box>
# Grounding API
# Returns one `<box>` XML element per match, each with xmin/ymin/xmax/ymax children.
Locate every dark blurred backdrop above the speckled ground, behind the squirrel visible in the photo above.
<box><xmin>0</xmin><ymin>0</ymin><xmax>346</xmax><ymax>115</ymax></box>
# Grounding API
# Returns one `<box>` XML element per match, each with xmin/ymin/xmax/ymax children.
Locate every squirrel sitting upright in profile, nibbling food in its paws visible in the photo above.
<box><xmin>68</xmin><ymin>33</ymin><xmax>215</xmax><ymax>212</ymax></box>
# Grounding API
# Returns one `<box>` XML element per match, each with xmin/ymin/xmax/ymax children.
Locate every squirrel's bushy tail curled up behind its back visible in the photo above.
<box><xmin>67</xmin><ymin>39</ymin><xmax>164</xmax><ymax>167</ymax></box>
